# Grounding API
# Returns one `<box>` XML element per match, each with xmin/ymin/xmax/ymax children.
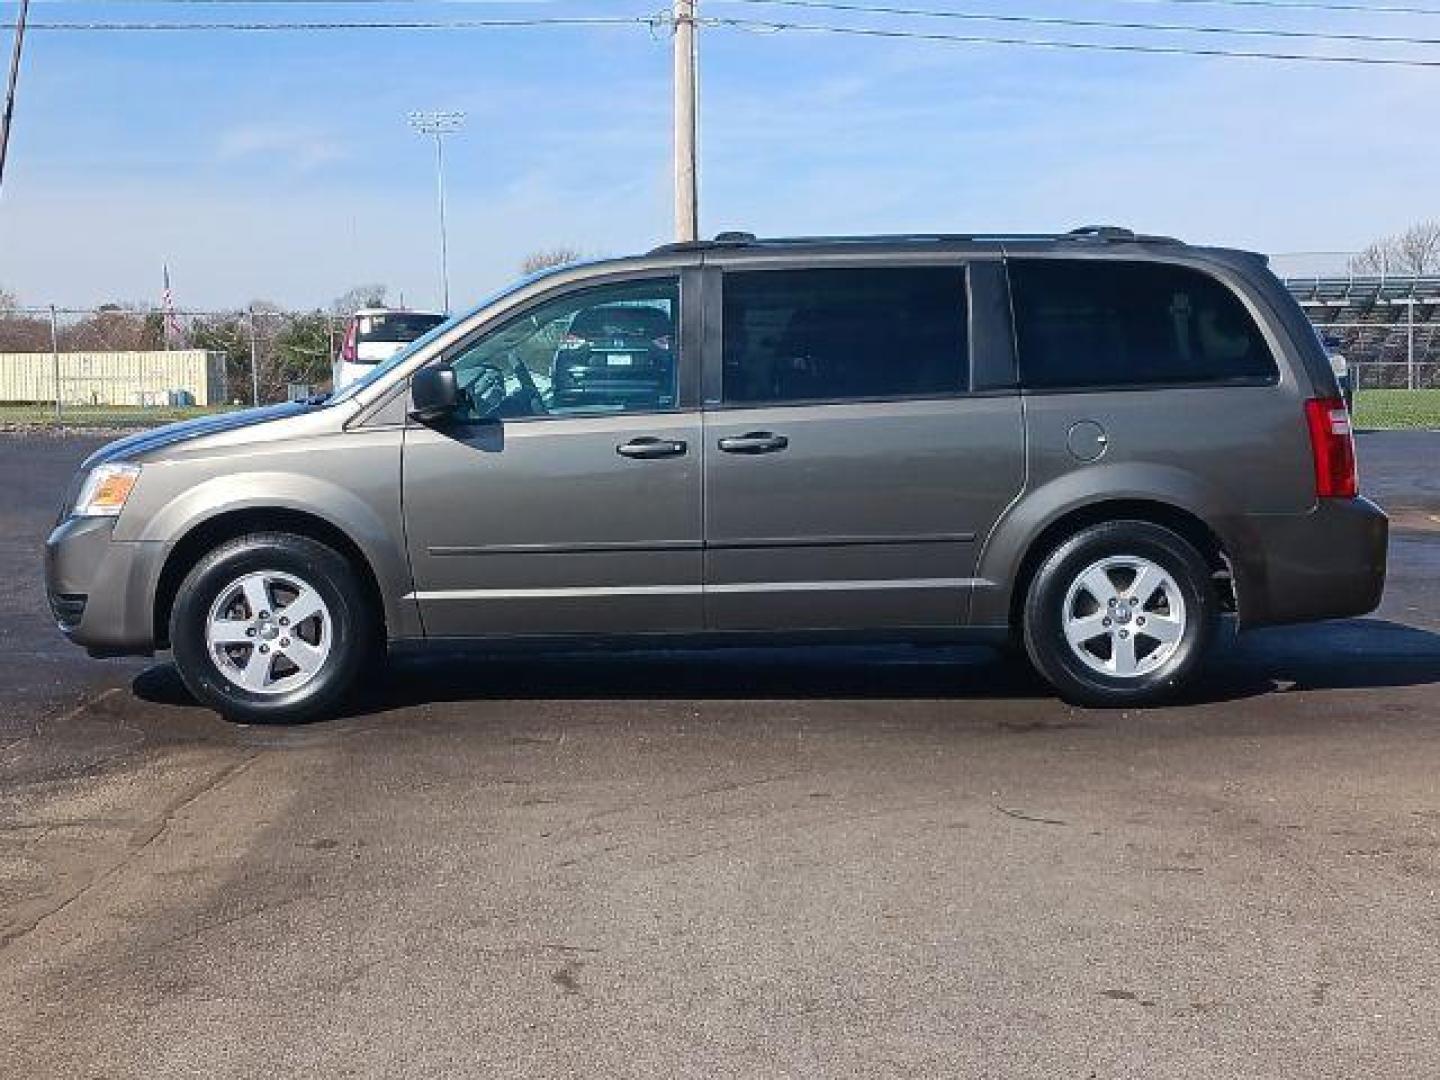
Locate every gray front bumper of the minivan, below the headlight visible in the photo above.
<box><xmin>45</xmin><ymin>517</ymin><xmax>166</xmax><ymax>657</ymax></box>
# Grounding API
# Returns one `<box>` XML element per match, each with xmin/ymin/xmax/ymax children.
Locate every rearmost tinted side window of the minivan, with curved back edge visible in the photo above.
<box><xmin>1009</xmin><ymin>259</ymin><xmax>1276</xmax><ymax>389</ymax></box>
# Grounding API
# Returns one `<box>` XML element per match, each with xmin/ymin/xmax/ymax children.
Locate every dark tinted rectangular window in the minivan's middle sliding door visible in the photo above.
<box><xmin>723</xmin><ymin>266</ymin><xmax>968</xmax><ymax>405</ymax></box>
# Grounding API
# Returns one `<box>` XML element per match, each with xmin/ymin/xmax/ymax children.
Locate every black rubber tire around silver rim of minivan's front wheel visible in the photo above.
<box><xmin>170</xmin><ymin>533</ymin><xmax>382</xmax><ymax>724</ymax></box>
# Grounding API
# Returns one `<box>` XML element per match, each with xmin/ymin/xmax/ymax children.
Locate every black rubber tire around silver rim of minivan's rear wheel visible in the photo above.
<box><xmin>1022</xmin><ymin>521</ymin><xmax>1220</xmax><ymax>708</ymax></box>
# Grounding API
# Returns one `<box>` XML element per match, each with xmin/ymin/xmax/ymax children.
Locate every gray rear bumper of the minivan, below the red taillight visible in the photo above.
<box><xmin>1231</xmin><ymin>498</ymin><xmax>1390</xmax><ymax>629</ymax></box>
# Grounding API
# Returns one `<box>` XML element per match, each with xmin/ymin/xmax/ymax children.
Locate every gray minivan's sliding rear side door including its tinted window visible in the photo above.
<box><xmin>704</xmin><ymin>265</ymin><xmax>1024</xmax><ymax>629</ymax></box>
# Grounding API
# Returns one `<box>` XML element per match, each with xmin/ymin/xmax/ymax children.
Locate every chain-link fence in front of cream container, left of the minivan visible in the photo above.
<box><xmin>0</xmin><ymin>305</ymin><xmax>347</xmax><ymax>426</ymax></box>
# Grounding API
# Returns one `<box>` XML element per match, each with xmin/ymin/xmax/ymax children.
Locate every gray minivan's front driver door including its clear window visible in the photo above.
<box><xmin>403</xmin><ymin>275</ymin><xmax>703</xmax><ymax>636</ymax></box>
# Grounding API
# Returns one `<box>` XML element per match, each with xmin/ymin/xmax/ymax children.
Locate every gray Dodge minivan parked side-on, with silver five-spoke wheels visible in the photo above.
<box><xmin>46</xmin><ymin>228</ymin><xmax>1387</xmax><ymax>721</ymax></box>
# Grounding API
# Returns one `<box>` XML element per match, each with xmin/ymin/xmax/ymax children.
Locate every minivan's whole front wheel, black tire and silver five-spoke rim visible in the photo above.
<box><xmin>170</xmin><ymin>533</ymin><xmax>374</xmax><ymax>723</ymax></box>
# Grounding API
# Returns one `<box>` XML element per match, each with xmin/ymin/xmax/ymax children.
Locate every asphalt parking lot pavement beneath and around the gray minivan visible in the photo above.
<box><xmin>0</xmin><ymin>433</ymin><xmax>1440</xmax><ymax>1079</ymax></box>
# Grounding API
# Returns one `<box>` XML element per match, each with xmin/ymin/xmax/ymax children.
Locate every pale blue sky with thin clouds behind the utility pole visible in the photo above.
<box><xmin>0</xmin><ymin>0</ymin><xmax>1440</xmax><ymax>307</ymax></box>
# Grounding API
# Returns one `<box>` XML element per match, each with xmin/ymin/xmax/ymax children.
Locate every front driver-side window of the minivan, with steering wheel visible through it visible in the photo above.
<box><xmin>451</xmin><ymin>278</ymin><xmax>680</xmax><ymax>422</ymax></box>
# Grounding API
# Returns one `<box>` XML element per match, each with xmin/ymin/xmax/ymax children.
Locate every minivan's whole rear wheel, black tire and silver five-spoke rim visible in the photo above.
<box><xmin>1024</xmin><ymin>521</ymin><xmax>1220</xmax><ymax>707</ymax></box>
